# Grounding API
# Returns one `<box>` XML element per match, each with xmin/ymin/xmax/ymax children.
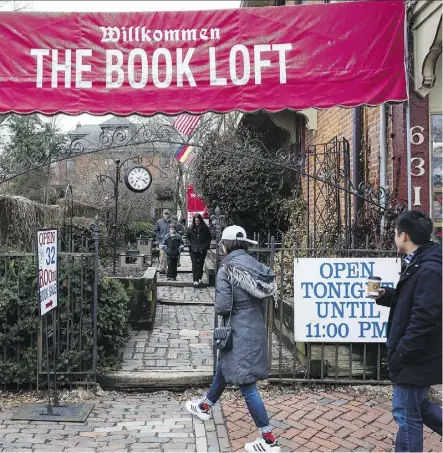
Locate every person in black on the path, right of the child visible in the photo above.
<box><xmin>186</xmin><ymin>214</ymin><xmax>212</xmax><ymax>287</ymax></box>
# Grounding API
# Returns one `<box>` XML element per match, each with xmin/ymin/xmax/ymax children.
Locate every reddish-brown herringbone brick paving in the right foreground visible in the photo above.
<box><xmin>222</xmin><ymin>390</ymin><xmax>442</xmax><ymax>452</ymax></box>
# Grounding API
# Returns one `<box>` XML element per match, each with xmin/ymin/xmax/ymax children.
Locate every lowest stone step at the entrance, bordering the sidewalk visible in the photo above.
<box><xmin>98</xmin><ymin>367</ymin><xmax>213</xmax><ymax>390</ymax></box>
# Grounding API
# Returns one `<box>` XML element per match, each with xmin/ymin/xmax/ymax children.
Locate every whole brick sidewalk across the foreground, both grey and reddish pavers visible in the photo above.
<box><xmin>0</xmin><ymin>386</ymin><xmax>442</xmax><ymax>453</ymax></box>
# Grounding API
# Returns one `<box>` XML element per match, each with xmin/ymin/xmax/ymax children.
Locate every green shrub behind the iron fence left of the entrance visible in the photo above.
<box><xmin>0</xmin><ymin>255</ymin><xmax>130</xmax><ymax>384</ymax></box>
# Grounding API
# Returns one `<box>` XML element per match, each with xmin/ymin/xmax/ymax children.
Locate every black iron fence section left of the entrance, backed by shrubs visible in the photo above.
<box><xmin>0</xmin><ymin>239</ymin><xmax>98</xmax><ymax>389</ymax></box>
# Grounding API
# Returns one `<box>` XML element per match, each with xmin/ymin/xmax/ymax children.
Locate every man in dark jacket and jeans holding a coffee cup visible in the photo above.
<box><xmin>376</xmin><ymin>211</ymin><xmax>442</xmax><ymax>452</ymax></box>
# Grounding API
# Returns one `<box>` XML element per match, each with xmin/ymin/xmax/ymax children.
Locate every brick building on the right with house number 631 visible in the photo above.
<box><xmin>241</xmin><ymin>0</ymin><xmax>442</xmax><ymax>242</ymax></box>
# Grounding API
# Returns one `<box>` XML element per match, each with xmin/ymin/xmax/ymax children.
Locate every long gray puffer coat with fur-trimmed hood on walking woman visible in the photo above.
<box><xmin>215</xmin><ymin>250</ymin><xmax>275</xmax><ymax>385</ymax></box>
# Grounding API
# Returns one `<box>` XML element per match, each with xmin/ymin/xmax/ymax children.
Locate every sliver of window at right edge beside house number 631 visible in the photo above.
<box><xmin>431</xmin><ymin>114</ymin><xmax>443</xmax><ymax>242</ymax></box>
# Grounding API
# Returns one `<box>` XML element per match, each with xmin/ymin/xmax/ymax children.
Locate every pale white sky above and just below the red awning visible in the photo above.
<box><xmin>2</xmin><ymin>0</ymin><xmax>240</xmax><ymax>132</ymax></box>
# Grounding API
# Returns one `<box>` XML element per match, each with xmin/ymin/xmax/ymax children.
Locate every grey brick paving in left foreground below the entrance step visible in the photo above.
<box><xmin>0</xmin><ymin>392</ymin><xmax>230</xmax><ymax>453</ymax></box>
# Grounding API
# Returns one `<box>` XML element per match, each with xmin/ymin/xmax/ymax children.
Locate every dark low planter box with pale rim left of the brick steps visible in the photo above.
<box><xmin>108</xmin><ymin>267</ymin><xmax>157</xmax><ymax>330</ymax></box>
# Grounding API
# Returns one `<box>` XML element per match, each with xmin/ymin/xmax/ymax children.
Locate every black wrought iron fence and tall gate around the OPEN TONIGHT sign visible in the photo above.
<box><xmin>214</xmin><ymin>138</ymin><xmax>403</xmax><ymax>384</ymax></box>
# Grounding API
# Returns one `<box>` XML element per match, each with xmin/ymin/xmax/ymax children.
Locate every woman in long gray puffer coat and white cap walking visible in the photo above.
<box><xmin>186</xmin><ymin>225</ymin><xmax>280</xmax><ymax>453</ymax></box>
